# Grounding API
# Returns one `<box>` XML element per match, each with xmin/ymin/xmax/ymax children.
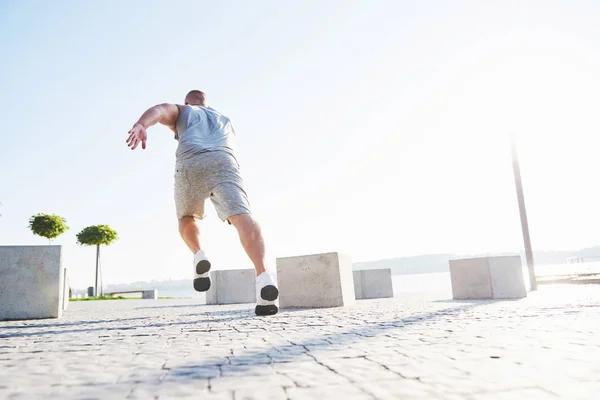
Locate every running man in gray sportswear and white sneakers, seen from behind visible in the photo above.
<box><xmin>127</xmin><ymin>90</ymin><xmax>279</xmax><ymax>315</ymax></box>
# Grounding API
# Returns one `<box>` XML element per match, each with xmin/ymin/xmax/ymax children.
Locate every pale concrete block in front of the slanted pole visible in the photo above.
<box><xmin>450</xmin><ymin>256</ymin><xmax>527</xmax><ymax>299</ymax></box>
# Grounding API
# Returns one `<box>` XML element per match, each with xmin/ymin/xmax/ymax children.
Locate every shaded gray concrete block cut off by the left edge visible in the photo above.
<box><xmin>0</xmin><ymin>246</ymin><xmax>65</xmax><ymax>320</ymax></box>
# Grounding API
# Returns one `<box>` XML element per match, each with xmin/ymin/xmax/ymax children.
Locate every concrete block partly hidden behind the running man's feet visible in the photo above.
<box><xmin>206</xmin><ymin>269</ymin><xmax>256</xmax><ymax>304</ymax></box>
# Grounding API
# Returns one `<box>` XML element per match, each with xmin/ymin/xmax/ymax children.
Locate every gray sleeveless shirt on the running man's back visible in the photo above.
<box><xmin>175</xmin><ymin>105</ymin><xmax>235</xmax><ymax>161</ymax></box>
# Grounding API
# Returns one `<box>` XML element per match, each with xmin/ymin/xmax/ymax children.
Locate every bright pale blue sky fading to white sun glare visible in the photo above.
<box><xmin>0</xmin><ymin>0</ymin><xmax>600</xmax><ymax>288</ymax></box>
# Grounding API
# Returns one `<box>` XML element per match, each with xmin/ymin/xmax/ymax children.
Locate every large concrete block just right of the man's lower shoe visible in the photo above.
<box><xmin>277</xmin><ymin>253</ymin><xmax>355</xmax><ymax>308</ymax></box>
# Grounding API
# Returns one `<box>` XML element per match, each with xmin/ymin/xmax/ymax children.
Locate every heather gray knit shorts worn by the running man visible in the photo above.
<box><xmin>175</xmin><ymin>151</ymin><xmax>250</xmax><ymax>221</ymax></box>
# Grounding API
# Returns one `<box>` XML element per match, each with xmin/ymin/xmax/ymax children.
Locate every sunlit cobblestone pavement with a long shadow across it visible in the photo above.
<box><xmin>0</xmin><ymin>285</ymin><xmax>600</xmax><ymax>400</ymax></box>
